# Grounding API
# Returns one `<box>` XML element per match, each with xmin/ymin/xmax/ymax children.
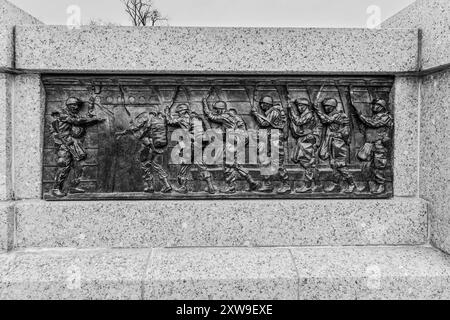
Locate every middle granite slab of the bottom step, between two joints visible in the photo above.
<box><xmin>143</xmin><ymin>248</ymin><xmax>298</xmax><ymax>300</ymax></box>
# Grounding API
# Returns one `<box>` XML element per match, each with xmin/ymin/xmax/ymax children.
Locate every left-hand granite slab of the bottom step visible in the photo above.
<box><xmin>0</xmin><ymin>249</ymin><xmax>150</xmax><ymax>300</ymax></box>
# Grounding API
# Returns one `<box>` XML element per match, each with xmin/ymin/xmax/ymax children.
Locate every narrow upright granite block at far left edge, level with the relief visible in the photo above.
<box><xmin>0</xmin><ymin>73</ymin><xmax>14</xmax><ymax>201</ymax></box>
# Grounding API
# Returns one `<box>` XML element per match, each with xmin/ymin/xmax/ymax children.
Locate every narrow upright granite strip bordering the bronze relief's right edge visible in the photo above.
<box><xmin>393</xmin><ymin>77</ymin><xmax>420</xmax><ymax>197</ymax></box>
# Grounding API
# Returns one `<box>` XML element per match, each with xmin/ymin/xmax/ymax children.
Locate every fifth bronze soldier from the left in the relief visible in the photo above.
<box><xmin>252</xmin><ymin>96</ymin><xmax>291</xmax><ymax>194</ymax></box>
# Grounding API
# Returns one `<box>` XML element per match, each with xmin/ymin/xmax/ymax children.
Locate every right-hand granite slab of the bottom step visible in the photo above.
<box><xmin>291</xmin><ymin>247</ymin><xmax>450</xmax><ymax>300</ymax></box>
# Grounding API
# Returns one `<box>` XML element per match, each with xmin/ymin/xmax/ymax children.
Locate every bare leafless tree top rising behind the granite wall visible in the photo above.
<box><xmin>122</xmin><ymin>0</ymin><xmax>169</xmax><ymax>26</ymax></box>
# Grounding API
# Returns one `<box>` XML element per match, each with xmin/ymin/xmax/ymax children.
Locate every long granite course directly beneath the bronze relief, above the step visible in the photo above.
<box><xmin>16</xmin><ymin>198</ymin><xmax>427</xmax><ymax>248</ymax></box>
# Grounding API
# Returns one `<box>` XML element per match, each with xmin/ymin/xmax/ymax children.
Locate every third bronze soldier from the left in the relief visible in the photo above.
<box><xmin>165</xmin><ymin>104</ymin><xmax>217</xmax><ymax>194</ymax></box>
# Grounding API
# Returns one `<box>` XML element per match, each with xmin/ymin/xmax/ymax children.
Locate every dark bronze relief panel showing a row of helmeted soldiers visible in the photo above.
<box><xmin>43</xmin><ymin>75</ymin><xmax>394</xmax><ymax>200</ymax></box>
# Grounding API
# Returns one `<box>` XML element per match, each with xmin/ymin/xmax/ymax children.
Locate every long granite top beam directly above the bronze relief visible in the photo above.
<box><xmin>16</xmin><ymin>26</ymin><xmax>418</xmax><ymax>73</ymax></box>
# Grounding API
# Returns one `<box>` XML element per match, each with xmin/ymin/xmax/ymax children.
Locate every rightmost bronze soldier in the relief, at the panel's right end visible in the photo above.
<box><xmin>350</xmin><ymin>94</ymin><xmax>394</xmax><ymax>194</ymax></box>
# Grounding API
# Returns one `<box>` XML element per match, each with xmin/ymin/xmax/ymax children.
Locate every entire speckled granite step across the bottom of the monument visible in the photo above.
<box><xmin>0</xmin><ymin>246</ymin><xmax>450</xmax><ymax>300</ymax></box>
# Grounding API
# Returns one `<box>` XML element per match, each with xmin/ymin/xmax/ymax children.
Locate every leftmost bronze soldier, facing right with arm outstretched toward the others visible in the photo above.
<box><xmin>50</xmin><ymin>97</ymin><xmax>104</xmax><ymax>197</ymax></box>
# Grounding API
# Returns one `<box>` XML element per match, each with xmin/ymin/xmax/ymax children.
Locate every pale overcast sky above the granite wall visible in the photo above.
<box><xmin>9</xmin><ymin>0</ymin><xmax>414</xmax><ymax>28</ymax></box>
